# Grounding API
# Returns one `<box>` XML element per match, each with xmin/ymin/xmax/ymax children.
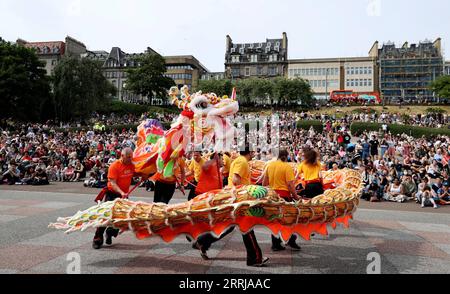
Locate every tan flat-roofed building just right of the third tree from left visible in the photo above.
<box><xmin>164</xmin><ymin>55</ymin><xmax>208</xmax><ymax>88</ymax></box>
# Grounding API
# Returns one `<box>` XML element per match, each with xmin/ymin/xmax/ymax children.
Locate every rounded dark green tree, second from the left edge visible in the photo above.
<box><xmin>52</xmin><ymin>57</ymin><xmax>116</xmax><ymax>121</ymax></box>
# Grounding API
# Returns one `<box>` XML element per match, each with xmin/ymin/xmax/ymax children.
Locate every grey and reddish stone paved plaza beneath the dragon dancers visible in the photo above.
<box><xmin>0</xmin><ymin>183</ymin><xmax>450</xmax><ymax>274</ymax></box>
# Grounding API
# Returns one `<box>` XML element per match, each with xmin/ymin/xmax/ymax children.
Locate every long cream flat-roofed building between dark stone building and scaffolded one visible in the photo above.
<box><xmin>287</xmin><ymin>57</ymin><xmax>378</xmax><ymax>99</ymax></box>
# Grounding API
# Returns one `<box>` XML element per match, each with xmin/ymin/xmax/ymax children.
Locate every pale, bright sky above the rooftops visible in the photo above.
<box><xmin>0</xmin><ymin>0</ymin><xmax>450</xmax><ymax>71</ymax></box>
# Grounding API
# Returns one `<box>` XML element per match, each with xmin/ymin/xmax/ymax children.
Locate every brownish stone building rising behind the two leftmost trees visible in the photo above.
<box><xmin>17</xmin><ymin>36</ymin><xmax>86</xmax><ymax>75</ymax></box>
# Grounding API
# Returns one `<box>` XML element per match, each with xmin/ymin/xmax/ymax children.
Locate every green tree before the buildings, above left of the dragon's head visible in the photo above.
<box><xmin>126</xmin><ymin>53</ymin><xmax>175</xmax><ymax>99</ymax></box>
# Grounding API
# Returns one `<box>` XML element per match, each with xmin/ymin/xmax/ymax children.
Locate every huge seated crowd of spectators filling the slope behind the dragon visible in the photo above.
<box><xmin>0</xmin><ymin>112</ymin><xmax>450</xmax><ymax>207</ymax></box>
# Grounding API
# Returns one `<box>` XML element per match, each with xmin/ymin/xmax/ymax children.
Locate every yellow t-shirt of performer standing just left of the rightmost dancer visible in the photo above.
<box><xmin>266</xmin><ymin>160</ymin><xmax>295</xmax><ymax>191</ymax></box>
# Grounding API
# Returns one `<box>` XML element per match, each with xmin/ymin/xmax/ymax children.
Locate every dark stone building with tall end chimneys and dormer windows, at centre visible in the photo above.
<box><xmin>225</xmin><ymin>33</ymin><xmax>288</xmax><ymax>80</ymax></box>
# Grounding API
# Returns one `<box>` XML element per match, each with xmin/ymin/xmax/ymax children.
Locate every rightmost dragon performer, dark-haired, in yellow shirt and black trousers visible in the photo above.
<box><xmin>298</xmin><ymin>149</ymin><xmax>324</xmax><ymax>199</ymax></box>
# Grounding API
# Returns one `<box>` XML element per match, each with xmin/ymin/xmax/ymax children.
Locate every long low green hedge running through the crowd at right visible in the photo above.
<box><xmin>350</xmin><ymin>122</ymin><xmax>450</xmax><ymax>138</ymax></box>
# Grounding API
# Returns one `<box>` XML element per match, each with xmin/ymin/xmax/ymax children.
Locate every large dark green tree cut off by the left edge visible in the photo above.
<box><xmin>0</xmin><ymin>40</ymin><xmax>50</xmax><ymax>121</ymax></box>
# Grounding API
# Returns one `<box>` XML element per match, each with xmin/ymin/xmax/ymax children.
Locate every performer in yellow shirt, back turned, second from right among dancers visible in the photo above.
<box><xmin>263</xmin><ymin>149</ymin><xmax>301</xmax><ymax>251</ymax></box>
